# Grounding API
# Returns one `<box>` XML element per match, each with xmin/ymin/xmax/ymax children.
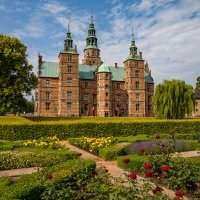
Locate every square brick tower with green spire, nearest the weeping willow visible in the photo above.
<box><xmin>124</xmin><ymin>34</ymin><xmax>145</xmax><ymax>117</ymax></box>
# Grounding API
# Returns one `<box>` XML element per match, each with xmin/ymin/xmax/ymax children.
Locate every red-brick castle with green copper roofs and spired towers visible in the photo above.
<box><xmin>35</xmin><ymin>20</ymin><xmax>154</xmax><ymax>117</ymax></box>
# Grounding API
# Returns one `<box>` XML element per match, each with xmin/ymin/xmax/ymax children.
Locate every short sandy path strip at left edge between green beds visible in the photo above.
<box><xmin>0</xmin><ymin>167</ymin><xmax>39</xmax><ymax>177</ymax></box>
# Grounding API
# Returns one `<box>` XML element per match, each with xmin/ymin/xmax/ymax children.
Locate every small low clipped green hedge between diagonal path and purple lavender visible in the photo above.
<box><xmin>99</xmin><ymin>143</ymin><xmax>127</xmax><ymax>160</ymax></box>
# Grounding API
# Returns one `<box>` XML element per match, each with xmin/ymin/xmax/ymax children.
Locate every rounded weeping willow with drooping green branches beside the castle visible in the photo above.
<box><xmin>153</xmin><ymin>80</ymin><xmax>195</xmax><ymax>119</ymax></box>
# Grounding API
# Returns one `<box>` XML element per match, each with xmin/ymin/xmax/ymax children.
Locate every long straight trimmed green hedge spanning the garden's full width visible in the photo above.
<box><xmin>0</xmin><ymin>120</ymin><xmax>200</xmax><ymax>140</ymax></box>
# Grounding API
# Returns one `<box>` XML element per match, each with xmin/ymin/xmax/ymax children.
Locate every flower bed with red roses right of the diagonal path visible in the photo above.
<box><xmin>117</xmin><ymin>155</ymin><xmax>200</xmax><ymax>197</ymax></box>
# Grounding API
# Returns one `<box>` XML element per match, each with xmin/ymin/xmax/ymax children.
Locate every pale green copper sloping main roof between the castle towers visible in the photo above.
<box><xmin>40</xmin><ymin>62</ymin><xmax>154</xmax><ymax>83</ymax></box>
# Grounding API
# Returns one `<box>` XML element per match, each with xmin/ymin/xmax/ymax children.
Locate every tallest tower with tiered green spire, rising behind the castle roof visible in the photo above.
<box><xmin>83</xmin><ymin>16</ymin><xmax>101</xmax><ymax>65</ymax></box>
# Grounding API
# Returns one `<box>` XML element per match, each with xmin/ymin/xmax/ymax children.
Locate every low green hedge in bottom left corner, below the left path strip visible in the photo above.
<box><xmin>0</xmin><ymin>160</ymin><xmax>95</xmax><ymax>200</ymax></box>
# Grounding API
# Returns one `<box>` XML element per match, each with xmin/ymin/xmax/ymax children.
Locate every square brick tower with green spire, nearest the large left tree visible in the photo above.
<box><xmin>58</xmin><ymin>27</ymin><xmax>79</xmax><ymax>116</ymax></box>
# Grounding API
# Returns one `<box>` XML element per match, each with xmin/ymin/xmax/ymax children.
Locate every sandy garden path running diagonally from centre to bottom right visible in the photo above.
<box><xmin>62</xmin><ymin>141</ymin><xmax>188</xmax><ymax>200</ymax></box>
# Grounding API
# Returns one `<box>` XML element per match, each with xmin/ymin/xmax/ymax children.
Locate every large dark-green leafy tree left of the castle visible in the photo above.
<box><xmin>0</xmin><ymin>34</ymin><xmax>37</xmax><ymax>112</ymax></box>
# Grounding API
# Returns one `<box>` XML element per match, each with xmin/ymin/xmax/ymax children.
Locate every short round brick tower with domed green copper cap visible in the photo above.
<box><xmin>97</xmin><ymin>64</ymin><xmax>112</xmax><ymax>117</ymax></box>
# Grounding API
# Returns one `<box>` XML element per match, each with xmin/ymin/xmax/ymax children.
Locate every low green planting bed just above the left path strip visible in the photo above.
<box><xmin>0</xmin><ymin>148</ymin><xmax>77</xmax><ymax>170</ymax></box>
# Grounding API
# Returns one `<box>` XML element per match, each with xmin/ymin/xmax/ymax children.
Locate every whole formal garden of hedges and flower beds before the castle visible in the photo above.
<box><xmin>0</xmin><ymin>116</ymin><xmax>200</xmax><ymax>200</ymax></box>
